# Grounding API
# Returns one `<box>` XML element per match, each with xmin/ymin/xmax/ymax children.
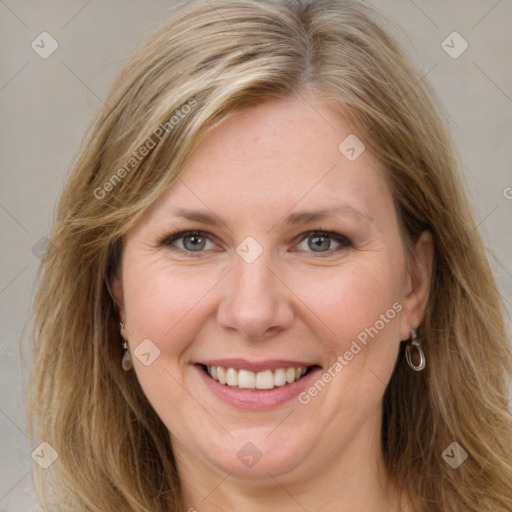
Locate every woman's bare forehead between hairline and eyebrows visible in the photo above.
<box><xmin>142</xmin><ymin>98</ymin><xmax>391</xmax><ymax>228</ymax></box>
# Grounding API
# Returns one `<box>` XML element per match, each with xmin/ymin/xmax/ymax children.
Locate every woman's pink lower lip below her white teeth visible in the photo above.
<box><xmin>195</xmin><ymin>364</ymin><xmax>321</xmax><ymax>411</ymax></box>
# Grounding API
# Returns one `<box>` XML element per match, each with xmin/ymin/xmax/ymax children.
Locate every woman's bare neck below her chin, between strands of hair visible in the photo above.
<box><xmin>172</xmin><ymin>410</ymin><xmax>410</xmax><ymax>512</ymax></box>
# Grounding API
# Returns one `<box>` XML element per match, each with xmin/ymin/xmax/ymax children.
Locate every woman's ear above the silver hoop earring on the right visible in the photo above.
<box><xmin>401</xmin><ymin>231</ymin><xmax>434</xmax><ymax>340</ymax></box>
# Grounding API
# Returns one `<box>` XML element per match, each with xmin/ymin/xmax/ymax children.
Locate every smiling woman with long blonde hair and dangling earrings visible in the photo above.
<box><xmin>29</xmin><ymin>0</ymin><xmax>512</xmax><ymax>512</ymax></box>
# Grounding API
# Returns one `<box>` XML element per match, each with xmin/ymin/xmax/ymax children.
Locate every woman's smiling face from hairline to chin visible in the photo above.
<box><xmin>114</xmin><ymin>98</ymin><xmax>428</xmax><ymax>488</ymax></box>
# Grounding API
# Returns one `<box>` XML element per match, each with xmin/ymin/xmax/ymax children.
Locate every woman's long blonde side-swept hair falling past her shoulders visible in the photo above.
<box><xmin>28</xmin><ymin>0</ymin><xmax>512</xmax><ymax>512</ymax></box>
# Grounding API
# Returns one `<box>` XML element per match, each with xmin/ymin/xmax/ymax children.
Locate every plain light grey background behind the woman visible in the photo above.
<box><xmin>0</xmin><ymin>0</ymin><xmax>512</xmax><ymax>512</ymax></box>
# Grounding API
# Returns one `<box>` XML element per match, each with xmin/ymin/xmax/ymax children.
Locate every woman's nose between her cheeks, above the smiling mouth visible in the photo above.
<box><xmin>217</xmin><ymin>251</ymin><xmax>294</xmax><ymax>341</ymax></box>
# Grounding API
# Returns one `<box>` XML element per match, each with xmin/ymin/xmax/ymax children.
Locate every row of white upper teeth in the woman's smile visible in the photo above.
<box><xmin>206</xmin><ymin>366</ymin><xmax>308</xmax><ymax>390</ymax></box>
